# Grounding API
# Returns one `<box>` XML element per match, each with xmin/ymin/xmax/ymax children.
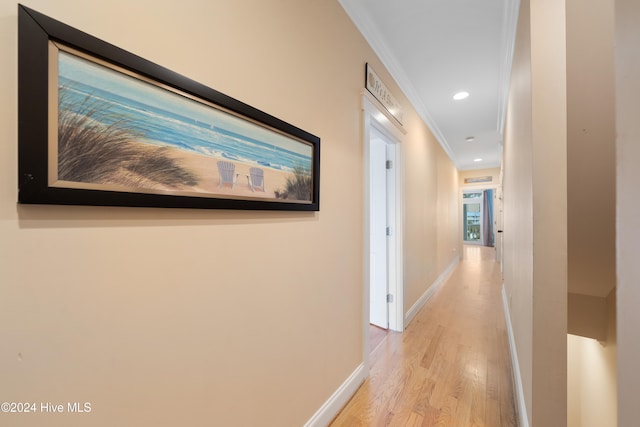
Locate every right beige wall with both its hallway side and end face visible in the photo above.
<box><xmin>503</xmin><ymin>0</ymin><xmax>567</xmax><ymax>426</ymax></box>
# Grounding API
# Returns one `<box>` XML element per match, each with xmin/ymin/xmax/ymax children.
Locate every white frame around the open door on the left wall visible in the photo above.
<box><xmin>362</xmin><ymin>90</ymin><xmax>406</xmax><ymax>370</ymax></box>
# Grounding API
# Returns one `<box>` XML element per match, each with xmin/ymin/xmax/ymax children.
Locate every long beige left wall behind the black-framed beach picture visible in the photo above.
<box><xmin>0</xmin><ymin>0</ymin><xmax>458</xmax><ymax>426</ymax></box>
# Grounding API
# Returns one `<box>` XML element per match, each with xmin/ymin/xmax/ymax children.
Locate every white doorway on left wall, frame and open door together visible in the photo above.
<box><xmin>362</xmin><ymin>90</ymin><xmax>406</xmax><ymax>342</ymax></box>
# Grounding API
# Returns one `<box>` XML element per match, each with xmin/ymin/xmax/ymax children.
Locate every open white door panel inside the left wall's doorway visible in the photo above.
<box><xmin>369</xmin><ymin>127</ymin><xmax>389</xmax><ymax>329</ymax></box>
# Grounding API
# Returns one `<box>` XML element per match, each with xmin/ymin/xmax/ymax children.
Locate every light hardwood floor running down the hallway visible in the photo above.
<box><xmin>331</xmin><ymin>246</ymin><xmax>517</xmax><ymax>427</ymax></box>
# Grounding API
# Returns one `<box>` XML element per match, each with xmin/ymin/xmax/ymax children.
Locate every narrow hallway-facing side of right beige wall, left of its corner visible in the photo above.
<box><xmin>502</xmin><ymin>0</ymin><xmax>533</xmax><ymax>424</ymax></box>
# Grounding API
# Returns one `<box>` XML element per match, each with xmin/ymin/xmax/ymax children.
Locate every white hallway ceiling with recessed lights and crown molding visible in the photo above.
<box><xmin>338</xmin><ymin>0</ymin><xmax>519</xmax><ymax>170</ymax></box>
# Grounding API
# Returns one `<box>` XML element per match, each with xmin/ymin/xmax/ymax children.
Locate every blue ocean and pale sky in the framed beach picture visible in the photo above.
<box><xmin>58</xmin><ymin>51</ymin><xmax>312</xmax><ymax>171</ymax></box>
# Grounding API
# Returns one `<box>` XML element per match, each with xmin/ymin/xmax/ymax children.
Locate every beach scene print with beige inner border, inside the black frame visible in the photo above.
<box><xmin>49</xmin><ymin>43</ymin><xmax>314</xmax><ymax>204</ymax></box>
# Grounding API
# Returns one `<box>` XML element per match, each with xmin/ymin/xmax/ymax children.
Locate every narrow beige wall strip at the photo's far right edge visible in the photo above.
<box><xmin>615</xmin><ymin>0</ymin><xmax>640</xmax><ymax>427</ymax></box>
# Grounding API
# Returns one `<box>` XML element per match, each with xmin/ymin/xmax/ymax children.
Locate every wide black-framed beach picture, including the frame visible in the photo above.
<box><xmin>18</xmin><ymin>6</ymin><xmax>320</xmax><ymax>211</ymax></box>
